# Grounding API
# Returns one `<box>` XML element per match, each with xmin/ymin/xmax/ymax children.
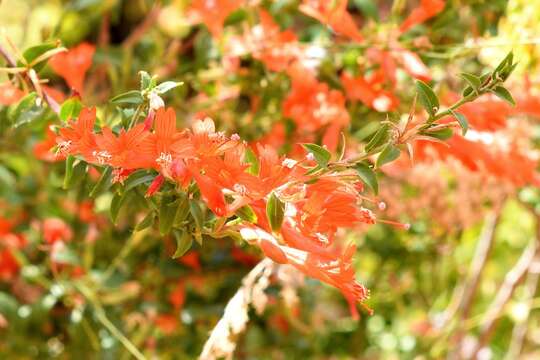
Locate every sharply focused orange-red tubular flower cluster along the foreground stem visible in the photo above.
<box><xmin>57</xmin><ymin>108</ymin><xmax>390</xmax><ymax>316</ymax></box>
